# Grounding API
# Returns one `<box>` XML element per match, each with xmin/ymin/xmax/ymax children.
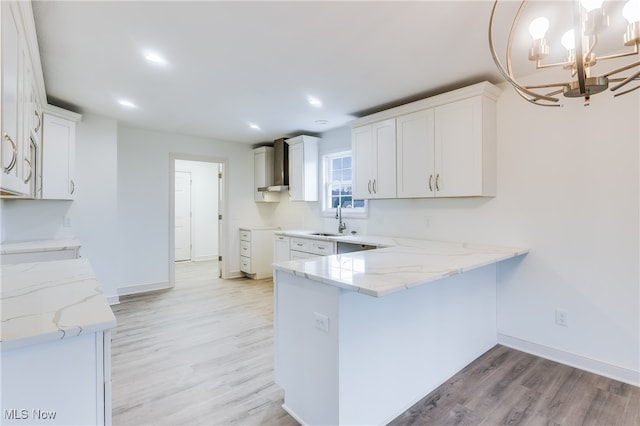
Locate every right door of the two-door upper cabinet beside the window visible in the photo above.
<box><xmin>371</xmin><ymin>119</ymin><xmax>396</xmax><ymax>198</ymax></box>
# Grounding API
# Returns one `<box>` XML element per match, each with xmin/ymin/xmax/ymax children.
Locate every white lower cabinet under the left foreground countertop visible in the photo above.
<box><xmin>1</xmin><ymin>331</ymin><xmax>111</xmax><ymax>425</ymax></box>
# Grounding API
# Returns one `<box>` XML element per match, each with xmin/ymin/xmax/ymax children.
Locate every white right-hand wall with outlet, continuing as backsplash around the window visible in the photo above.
<box><xmin>288</xmin><ymin>85</ymin><xmax>640</xmax><ymax>384</ymax></box>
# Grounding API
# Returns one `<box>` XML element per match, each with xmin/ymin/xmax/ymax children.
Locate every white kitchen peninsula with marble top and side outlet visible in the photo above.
<box><xmin>274</xmin><ymin>236</ymin><xmax>527</xmax><ymax>425</ymax></box>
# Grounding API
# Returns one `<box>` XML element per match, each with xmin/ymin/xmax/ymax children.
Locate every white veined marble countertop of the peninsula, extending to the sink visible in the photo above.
<box><xmin>273</xmin><ymin>236</ymin><xmax>528</xmax><ymax>297</ymax></box>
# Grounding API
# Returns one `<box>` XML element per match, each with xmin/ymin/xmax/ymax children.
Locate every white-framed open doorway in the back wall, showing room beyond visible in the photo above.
<box><xmin>169</xmin><ymin>154</ymin><xmax>226</xmax><ymax>287</ymax></box>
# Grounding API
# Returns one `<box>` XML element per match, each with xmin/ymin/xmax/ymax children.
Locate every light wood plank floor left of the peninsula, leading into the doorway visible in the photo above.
<box><xmin>112</xmin><ymin>262</ymin><xmax>298</xmax><ymax>425</ymax></box>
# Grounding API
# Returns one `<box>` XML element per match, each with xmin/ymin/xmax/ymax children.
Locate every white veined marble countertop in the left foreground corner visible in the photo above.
<box><xmin>0</xmin><ymin>259</ymin><xmax>116</xmax><ymax>350</ymax></box>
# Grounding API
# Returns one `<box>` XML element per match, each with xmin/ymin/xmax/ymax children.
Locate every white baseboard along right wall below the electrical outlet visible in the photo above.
<box><xmin>498</xmin><ymin>333</ymin><xmax>640</xmax><ymax>386</ymax></box>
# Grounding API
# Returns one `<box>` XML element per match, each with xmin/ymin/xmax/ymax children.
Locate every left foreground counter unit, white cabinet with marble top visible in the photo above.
<box><xmin>0</xmin><ymin>259</ymin><xmax>116</xmax><ymax>425</ymax></box>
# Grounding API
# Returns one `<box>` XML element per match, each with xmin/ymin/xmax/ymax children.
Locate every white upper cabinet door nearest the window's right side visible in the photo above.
<box><xmin>351</xmin><ymin>125</ymin><xmax>375</xmax><ymax>199</ymax></box>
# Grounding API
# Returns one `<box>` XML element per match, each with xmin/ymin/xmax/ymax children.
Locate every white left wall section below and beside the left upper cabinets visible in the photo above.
<box><xmin>2</xmin><ymin>115</ymin><xmax>121</xmax><ymax>298</ymax></box>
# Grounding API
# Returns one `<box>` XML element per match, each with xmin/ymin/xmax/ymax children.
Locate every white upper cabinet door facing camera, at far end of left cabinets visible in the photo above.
<box><xmin>42</xmin><ymin>114</ymin><xmax>76</xmax><ymax>200</ymax></box>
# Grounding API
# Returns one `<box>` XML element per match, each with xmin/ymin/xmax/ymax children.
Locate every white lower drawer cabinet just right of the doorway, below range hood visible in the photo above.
<box><xmin>240</xmin><ymin>227</ymin><xmax>278</xmax><ymax>280</ymax></box>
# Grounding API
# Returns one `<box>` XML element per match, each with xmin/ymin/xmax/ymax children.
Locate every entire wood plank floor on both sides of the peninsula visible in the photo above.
<box><xmin>112</xmin><ymin>262</ymin><xmax>640</xmax><ymax>426</ymax></box>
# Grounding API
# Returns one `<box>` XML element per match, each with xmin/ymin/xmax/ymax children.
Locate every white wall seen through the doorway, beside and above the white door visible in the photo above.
<box><xmin>176</xmin><ymin>160</ymin><xmax>219</xmax><ymax>260</ymax></box>
